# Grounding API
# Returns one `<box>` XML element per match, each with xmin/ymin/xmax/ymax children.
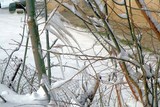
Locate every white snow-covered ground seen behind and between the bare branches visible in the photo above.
<box><xmin>0</xmin><ymin>9</ymin><xmax>145</xmax><ymax>107</ymax></box>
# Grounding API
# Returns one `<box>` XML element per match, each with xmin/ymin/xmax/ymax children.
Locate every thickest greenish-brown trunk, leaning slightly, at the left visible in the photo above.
<box><xmin>26</xmin><ymin>0</ymin><xmax>46</xmax><ymax>82</ymax></box>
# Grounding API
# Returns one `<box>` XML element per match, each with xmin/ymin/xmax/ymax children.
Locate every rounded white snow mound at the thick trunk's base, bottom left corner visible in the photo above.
<box><xmin>0</xmin><ymin>84</ymin><xmax>47</xmax><ymax>107</ymax></box>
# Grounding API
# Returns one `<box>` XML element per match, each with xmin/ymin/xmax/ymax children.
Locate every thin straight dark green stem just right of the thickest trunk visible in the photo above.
<box><xmin>44</xmin><ymin>0</ymin><xmax>51</xmax><ymax>84</ymax></box>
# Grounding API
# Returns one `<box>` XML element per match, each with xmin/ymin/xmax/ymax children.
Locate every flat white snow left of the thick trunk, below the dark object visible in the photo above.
<box><xmin>0</xmin><ymin>9</ymin><xmax>34</xmax><ymax>65</ymax></box>
